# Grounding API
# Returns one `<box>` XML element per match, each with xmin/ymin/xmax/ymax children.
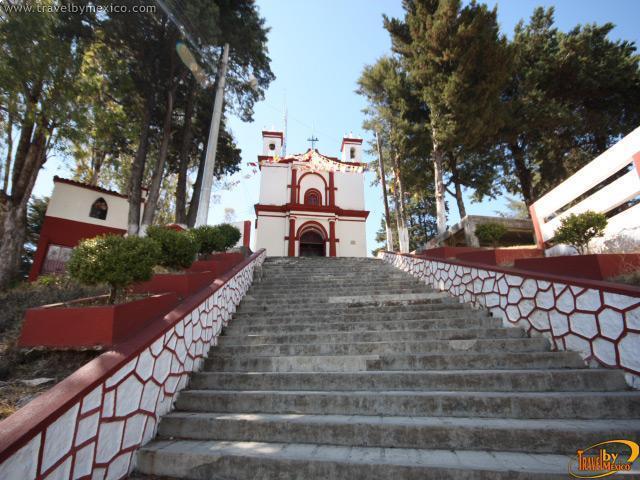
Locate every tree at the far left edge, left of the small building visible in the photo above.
<box><xmin>0</xmin><ymin>1</ymin><xmax>92</xmax><ymax>289</ymax></box>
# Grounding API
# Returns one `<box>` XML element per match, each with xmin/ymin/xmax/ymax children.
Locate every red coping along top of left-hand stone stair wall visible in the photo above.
<box><xmin>0</xmin><ymin>249</ymin><xmax>265</xmax><ymax>463</ymax></box>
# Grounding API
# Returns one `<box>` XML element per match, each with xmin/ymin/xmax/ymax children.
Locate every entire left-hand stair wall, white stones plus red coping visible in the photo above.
<box><xmin>0</xmin><ymin>250</ymin><xmax>266</xmax><ymax>480</ymax></box>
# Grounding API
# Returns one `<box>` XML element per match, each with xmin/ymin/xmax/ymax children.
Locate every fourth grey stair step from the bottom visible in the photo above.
<box><xmin>190</xmin><ymin>369</ymin><xmax>626</xmax><ymax>392</ymax></box>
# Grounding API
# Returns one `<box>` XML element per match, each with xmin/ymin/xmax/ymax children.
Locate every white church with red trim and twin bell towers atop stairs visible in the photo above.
<box><xmin>255</xmin><ymin>131</ymin><xmax>369</xmax><ymax>257</ymax></box>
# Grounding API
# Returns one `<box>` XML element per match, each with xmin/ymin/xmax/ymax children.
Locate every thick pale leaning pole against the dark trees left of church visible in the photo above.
<box><xmin>196</xmin><ymin>43</ymin><xmax>229</xmax><ymax>227</ymax></box>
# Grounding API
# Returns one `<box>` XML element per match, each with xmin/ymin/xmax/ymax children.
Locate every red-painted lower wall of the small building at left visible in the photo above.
<box><xmin>29</xmin><ymin>216</ymin><xmax>127</xmax><ymax>281</ymax></box>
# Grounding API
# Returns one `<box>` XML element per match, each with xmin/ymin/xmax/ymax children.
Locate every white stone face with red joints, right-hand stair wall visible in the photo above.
<box><xmin>380</xmin><ymin>252</ymin><xmax>640</xmax><ymax>388</ymax></box>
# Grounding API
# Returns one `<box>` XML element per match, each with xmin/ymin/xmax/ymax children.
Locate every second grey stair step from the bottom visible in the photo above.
<box><xmin>158</xmin><ymin>412</ymin><xmax>640</xmax><ymax>455</ymax></box>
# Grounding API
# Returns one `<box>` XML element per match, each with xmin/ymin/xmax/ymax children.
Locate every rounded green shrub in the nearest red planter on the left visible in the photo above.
<box><xmin>67</xmin><ymin>235</ymin><xmax>160</xmax><ymax>303</ymax></box>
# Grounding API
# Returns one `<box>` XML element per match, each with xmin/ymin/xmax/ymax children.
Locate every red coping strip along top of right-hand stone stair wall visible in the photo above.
<box><xmin>385</xmin><ymin>250</ymin><xmax>640</xmax><ymax>297</ymax></box>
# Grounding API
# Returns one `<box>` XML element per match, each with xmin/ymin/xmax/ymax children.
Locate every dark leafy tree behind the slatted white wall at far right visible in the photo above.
<box><xmin>492</xmin><ymin>8</ymin><xmax>640</xmax><ymax>206</ymax></box>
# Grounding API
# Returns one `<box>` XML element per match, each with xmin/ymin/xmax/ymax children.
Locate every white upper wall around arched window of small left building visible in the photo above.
<box><xmin>47</xmin><ymin>182</ymin><xmax>129</xmax><ymax>230</ymax></box>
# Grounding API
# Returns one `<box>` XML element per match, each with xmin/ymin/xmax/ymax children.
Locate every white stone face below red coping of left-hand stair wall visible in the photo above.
<box><xmin>0</xmin><ymin>251</ymin><xmax>266</xmax><ymax>480</ymax></box>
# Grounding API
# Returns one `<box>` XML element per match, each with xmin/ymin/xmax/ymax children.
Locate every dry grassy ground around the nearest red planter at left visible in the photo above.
<box><xmin>0</xmin><ymin>277</ymin><xmax>105</xmax><ymax>419</ymax></box>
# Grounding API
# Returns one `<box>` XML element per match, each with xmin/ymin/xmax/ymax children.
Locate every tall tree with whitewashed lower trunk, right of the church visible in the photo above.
<box><xmin>385</xmin><ymin>0</ymin><xmax>510</xmax><ymax>234</ymax></box>
